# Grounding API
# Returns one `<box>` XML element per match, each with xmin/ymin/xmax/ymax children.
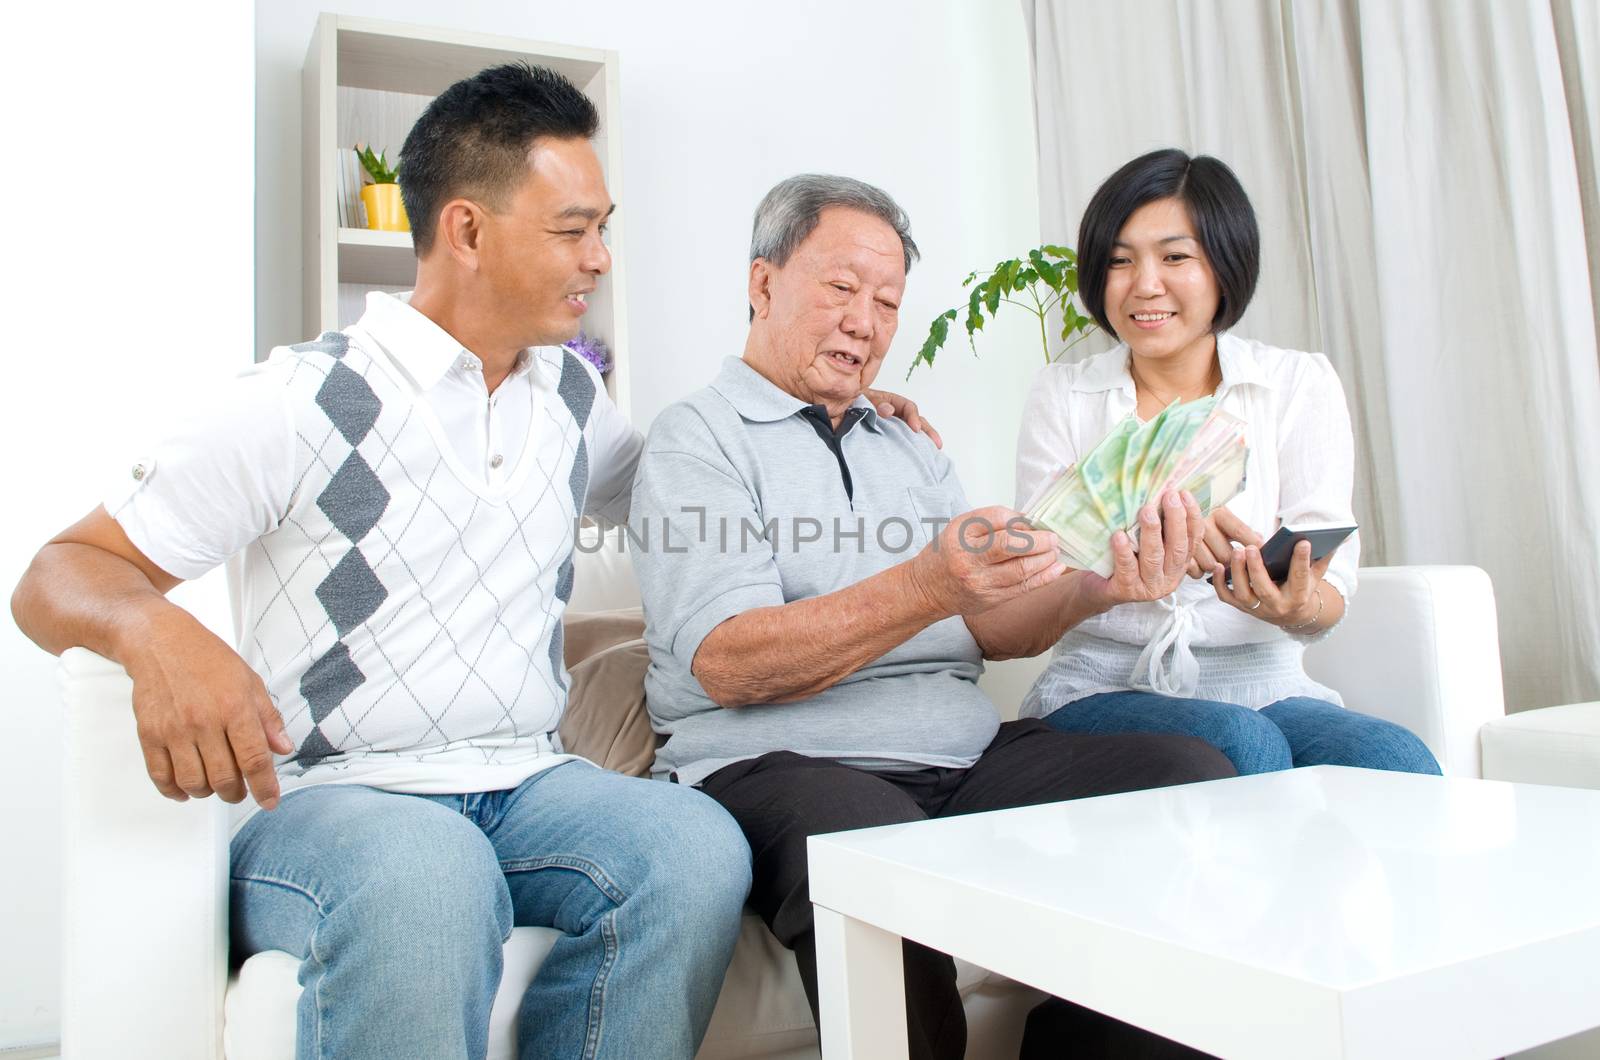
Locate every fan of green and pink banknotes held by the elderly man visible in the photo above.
<box><xmin>1022</xmin><ymin>397</ymin><xmax>1250</xmax><ymax>576</ymax></box>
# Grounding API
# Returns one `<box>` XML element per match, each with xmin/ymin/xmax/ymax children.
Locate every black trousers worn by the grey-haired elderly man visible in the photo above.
<box><xmin>701</xmin><ymin>723</ymin><xmax>1234</xmax><ymax>1060</ymax></box>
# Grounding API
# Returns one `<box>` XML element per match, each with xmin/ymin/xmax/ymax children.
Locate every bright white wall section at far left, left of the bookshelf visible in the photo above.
<box><xmin>0</xmin><ymin>0</ymin><xmax>253</xmax><ymax>1049</ymax></box>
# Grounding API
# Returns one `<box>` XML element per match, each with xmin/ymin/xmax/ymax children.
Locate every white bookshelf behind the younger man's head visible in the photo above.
<box><xmin>301</xmin><ymin>14</ymin><xmax>630</xmax><ymax>413</ymax></box>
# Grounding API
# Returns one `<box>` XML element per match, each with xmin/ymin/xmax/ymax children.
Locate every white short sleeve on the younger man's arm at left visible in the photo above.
<box><xmin>102</xmin><ymin>370</ymin><xmax>294</xmax><ymax>581</ymax></box>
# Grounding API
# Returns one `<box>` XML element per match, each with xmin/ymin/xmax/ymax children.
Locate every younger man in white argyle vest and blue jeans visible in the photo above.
<box><xmin>13</xmin><ymin>66</ymin><xmax>750</xmax><ymax>1060</ymax></box>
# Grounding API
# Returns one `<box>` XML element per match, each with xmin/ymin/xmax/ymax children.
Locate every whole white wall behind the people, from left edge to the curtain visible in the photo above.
<box><xmin>0</xmin><ymin>0</ymin><xmax>1038</xmax><ymax>1049</ymax></box>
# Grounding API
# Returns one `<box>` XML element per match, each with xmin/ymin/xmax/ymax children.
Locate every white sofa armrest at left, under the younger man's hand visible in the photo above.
<box><xmin>58</xmin><ymin>648</ymin><xmax>229</xmax><ymax>1060</ymax></box>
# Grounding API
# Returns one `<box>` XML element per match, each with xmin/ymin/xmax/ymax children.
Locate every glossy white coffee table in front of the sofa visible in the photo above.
<box><xmin>810</xmin><ymin>767</ymin><xmax>1600</xmax><ymax>1060</ymax></box>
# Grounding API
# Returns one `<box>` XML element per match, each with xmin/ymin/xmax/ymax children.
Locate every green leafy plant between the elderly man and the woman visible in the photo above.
<box><xmin>906</xmin><ymin>243</ymin><xmax>1094</xmax><ymax>378</ymax></box>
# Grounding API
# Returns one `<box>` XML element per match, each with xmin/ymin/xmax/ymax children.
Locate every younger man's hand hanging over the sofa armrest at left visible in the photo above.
<box><xmin>123</xmin><ymin>607</ymin><xmax>294</xmax><ymax>810</ymax></box>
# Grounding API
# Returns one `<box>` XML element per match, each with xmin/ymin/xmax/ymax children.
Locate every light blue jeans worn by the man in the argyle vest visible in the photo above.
<box><xmin>230</xmin><ymin>762</ymin><xmax>750</xmax><ymax>1060</ymax></box>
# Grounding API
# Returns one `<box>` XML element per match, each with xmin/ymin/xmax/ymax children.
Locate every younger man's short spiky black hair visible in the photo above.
<box><xmin>400</xmin><ymin>62</ymin><xmax>600</xmax><ymax>256</ymax></box>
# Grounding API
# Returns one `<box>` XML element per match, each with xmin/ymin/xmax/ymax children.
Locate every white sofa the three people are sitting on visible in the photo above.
<box><xmin>59</xmin><ymin>560</ymin><xmax>1504</xmax><ymax>1060</ymax></box>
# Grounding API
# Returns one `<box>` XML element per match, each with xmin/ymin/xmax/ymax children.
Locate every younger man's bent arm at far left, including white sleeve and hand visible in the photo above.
<box><xmin>11</xmin><ymin>368</ymin><xmax>296</xmax><ymax>807</ymax></box>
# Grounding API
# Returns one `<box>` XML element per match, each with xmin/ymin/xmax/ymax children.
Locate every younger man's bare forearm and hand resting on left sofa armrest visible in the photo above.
<box><xmin>11</xmin><ymin>508</ymin><xmax>294</xmax><ymax>809</ymax></box>
